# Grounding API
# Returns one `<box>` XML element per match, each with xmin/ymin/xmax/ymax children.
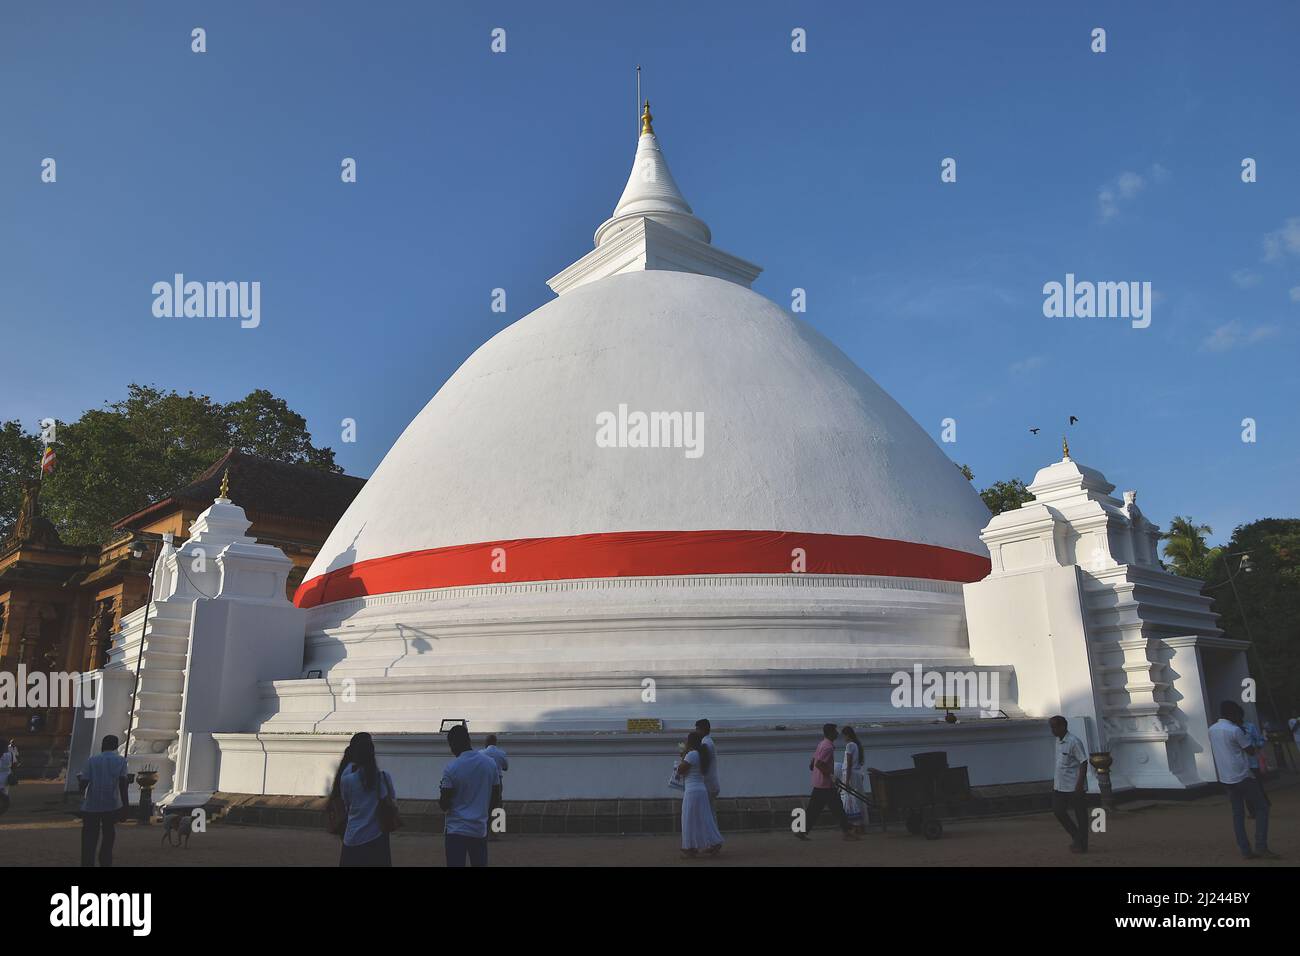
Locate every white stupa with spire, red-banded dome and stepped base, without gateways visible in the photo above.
<box><xmin>279</xmin><ymin>100</ymin><xmax>989</xmax><ymax>731</ymax></box>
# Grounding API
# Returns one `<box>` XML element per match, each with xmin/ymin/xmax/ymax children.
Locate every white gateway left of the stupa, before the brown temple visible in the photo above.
<box><xmin>69</xmin><ymin>483</ymin><xmax>306</xmax><ymax>805</ymax></box>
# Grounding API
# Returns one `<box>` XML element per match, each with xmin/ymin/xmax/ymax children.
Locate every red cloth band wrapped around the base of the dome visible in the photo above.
<box><xmin>294</xmin><ymin>531</ymin><xmax>991</xmax><ymax>607</ymax></box>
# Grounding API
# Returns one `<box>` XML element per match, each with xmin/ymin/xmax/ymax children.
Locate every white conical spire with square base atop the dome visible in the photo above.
<box><xmin>547</xmin><ymin>100</ymin><xmax>763</xmax><ymax>295</ymax></box>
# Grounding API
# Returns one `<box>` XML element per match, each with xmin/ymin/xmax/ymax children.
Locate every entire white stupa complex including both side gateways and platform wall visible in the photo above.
<box><xmin>65</xmin><ymin>104</ymin><xmax>1245</xmax><ymax>805</ymax></box>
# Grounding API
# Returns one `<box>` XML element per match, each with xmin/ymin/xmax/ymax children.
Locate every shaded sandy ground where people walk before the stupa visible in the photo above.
<box><xmin>0</xmin><ymin>777</ymin><xmax>1300</xmax><ymax>868</ymax></box>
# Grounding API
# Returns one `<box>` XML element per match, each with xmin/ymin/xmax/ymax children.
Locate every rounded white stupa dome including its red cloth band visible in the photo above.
<box><xmin>300</xmin><ymin>271</ymin><xmax>988</xmax><ymax>605</ymax></box>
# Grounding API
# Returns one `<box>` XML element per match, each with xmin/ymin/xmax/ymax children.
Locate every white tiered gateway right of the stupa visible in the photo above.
<box><xmin>965</xmin><ymin>450</ymin><xmax>1247</xmax><ymax>790</ymax></box>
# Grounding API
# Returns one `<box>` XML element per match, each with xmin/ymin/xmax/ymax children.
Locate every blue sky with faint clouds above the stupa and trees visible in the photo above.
<box><xmin>0</xmin><ymin>0</ymin><xmax>1300</xmax><ymax>540</ymax></box>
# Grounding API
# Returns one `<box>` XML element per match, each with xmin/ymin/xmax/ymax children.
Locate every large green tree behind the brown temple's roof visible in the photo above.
<box><xmin>0</xmin><ymin>385</ymin><xmax>339</xmax><ymax>544</ymax></box>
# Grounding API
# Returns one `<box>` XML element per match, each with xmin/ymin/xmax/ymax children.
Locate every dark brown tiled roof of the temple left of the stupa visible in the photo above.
<box><xmin>113</xmin><ymin>451</ymin><xmax>365</xmax><ymax>528</ymax></box>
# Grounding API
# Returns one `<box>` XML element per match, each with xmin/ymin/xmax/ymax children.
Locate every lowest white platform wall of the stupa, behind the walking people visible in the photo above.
<box><xmin>213</xmin><ymin>715</ymin><xmax>1054</xmax><ymax>800</ymax></box>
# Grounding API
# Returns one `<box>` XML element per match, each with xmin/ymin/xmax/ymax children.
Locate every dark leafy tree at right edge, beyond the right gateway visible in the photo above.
<box><xmin>1205</xmin><ymin>518</ymin><xmax>1300</xmax><ymax>719</ymax></box>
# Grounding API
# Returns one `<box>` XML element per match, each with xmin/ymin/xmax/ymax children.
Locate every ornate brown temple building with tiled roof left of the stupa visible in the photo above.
<box><xmin>0</xmin><ymin>450</ymin><xmax>365</xmax><ymax>775</ymax></box>
